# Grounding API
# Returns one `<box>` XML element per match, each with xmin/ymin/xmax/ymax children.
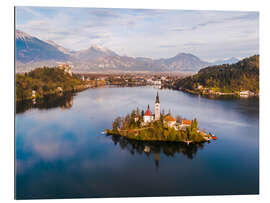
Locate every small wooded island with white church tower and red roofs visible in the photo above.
<box><xmin>106</xmin><ymin>93</ymin><xmax>216</xmax><ymax>144</ymax></box>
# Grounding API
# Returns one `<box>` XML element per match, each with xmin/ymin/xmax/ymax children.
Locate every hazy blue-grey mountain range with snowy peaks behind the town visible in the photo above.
<box><xmin>15</xmin><ymin>30</ymin><xmax>238</xmax><ymax>72</ymax></box>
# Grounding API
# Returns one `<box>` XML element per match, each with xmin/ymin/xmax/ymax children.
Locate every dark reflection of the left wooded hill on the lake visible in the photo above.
<box><xmin>16</xmin><ymin>92</ymin><xmax>75</xmax><ymax>113</ymax></box>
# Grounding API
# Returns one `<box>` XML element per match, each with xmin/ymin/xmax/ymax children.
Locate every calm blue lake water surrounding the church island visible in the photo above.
<box><xmin>15</xmin><ymin>87</ymin><xmax>259</xmax><ymax>199</ymax></box>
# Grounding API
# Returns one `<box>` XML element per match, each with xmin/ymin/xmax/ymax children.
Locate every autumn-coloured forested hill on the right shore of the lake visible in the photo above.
<box><xmin>173</xmin><ymin>55</ymin><xmax>259</xmax><ymax>96</ymax></box>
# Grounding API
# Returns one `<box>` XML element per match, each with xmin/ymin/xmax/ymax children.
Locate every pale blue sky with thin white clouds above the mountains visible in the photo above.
<box><xmin>15</xmin><ymin>7</ymin><xmax>259</xmax><ymax>62</ymax></box>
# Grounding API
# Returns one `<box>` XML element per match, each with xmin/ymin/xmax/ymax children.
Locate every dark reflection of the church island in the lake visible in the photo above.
<box><xmin>106</xmin><ymin>135</ymin><xmax>204</xmax><ymax>169</ymax></box>
